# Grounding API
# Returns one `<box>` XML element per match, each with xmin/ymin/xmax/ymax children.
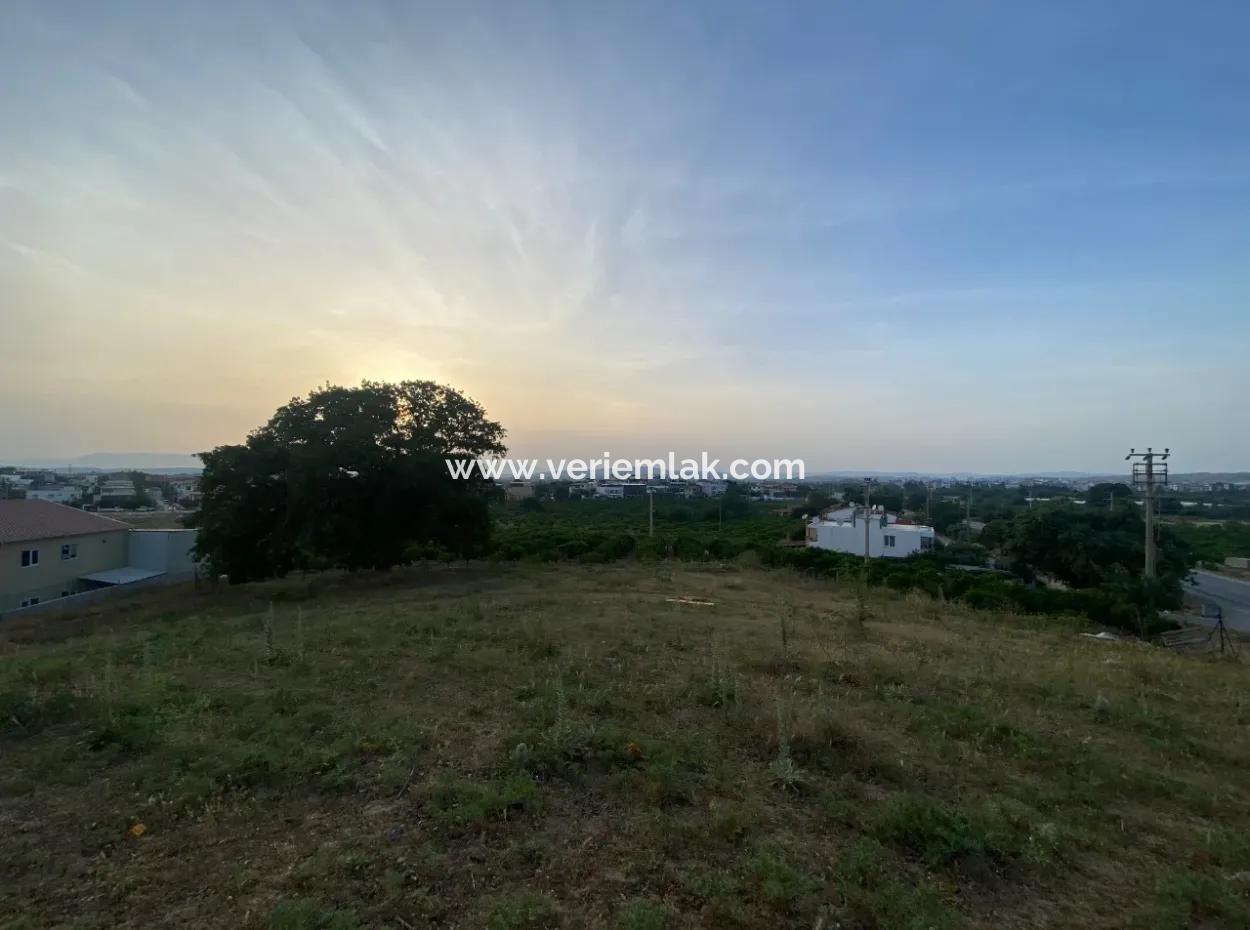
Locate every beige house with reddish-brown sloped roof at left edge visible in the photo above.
<box><xmin>0</xmin><ymin>500</ymin><xmax>130</xmax><ymax>613</ymax></box>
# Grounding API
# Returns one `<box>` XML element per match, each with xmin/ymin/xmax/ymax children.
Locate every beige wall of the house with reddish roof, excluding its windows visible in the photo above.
<box><xmin>0</xmin><ymin>530</ymin><xmax>129</xmax><ymax>610</ymax></box>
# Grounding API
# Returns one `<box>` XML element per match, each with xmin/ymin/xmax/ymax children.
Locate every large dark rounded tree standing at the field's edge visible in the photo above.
<box><xmin>198</xmin><ymin>381</ymin><xmax>506</xmax><ymax>581</ymax></box>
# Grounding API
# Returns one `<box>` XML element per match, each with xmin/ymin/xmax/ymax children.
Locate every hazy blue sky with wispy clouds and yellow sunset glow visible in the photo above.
<box><xmin>0</xmin><ymin>0</ymin><xmax>1250</xmax><ymax>473</ymax></box>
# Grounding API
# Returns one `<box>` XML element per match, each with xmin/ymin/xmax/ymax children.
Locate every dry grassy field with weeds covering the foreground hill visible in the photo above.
<box><xmin>0</xmin><ymin>564</ymin><xmax>1250</xmax><ymax>930</ymax></box>
